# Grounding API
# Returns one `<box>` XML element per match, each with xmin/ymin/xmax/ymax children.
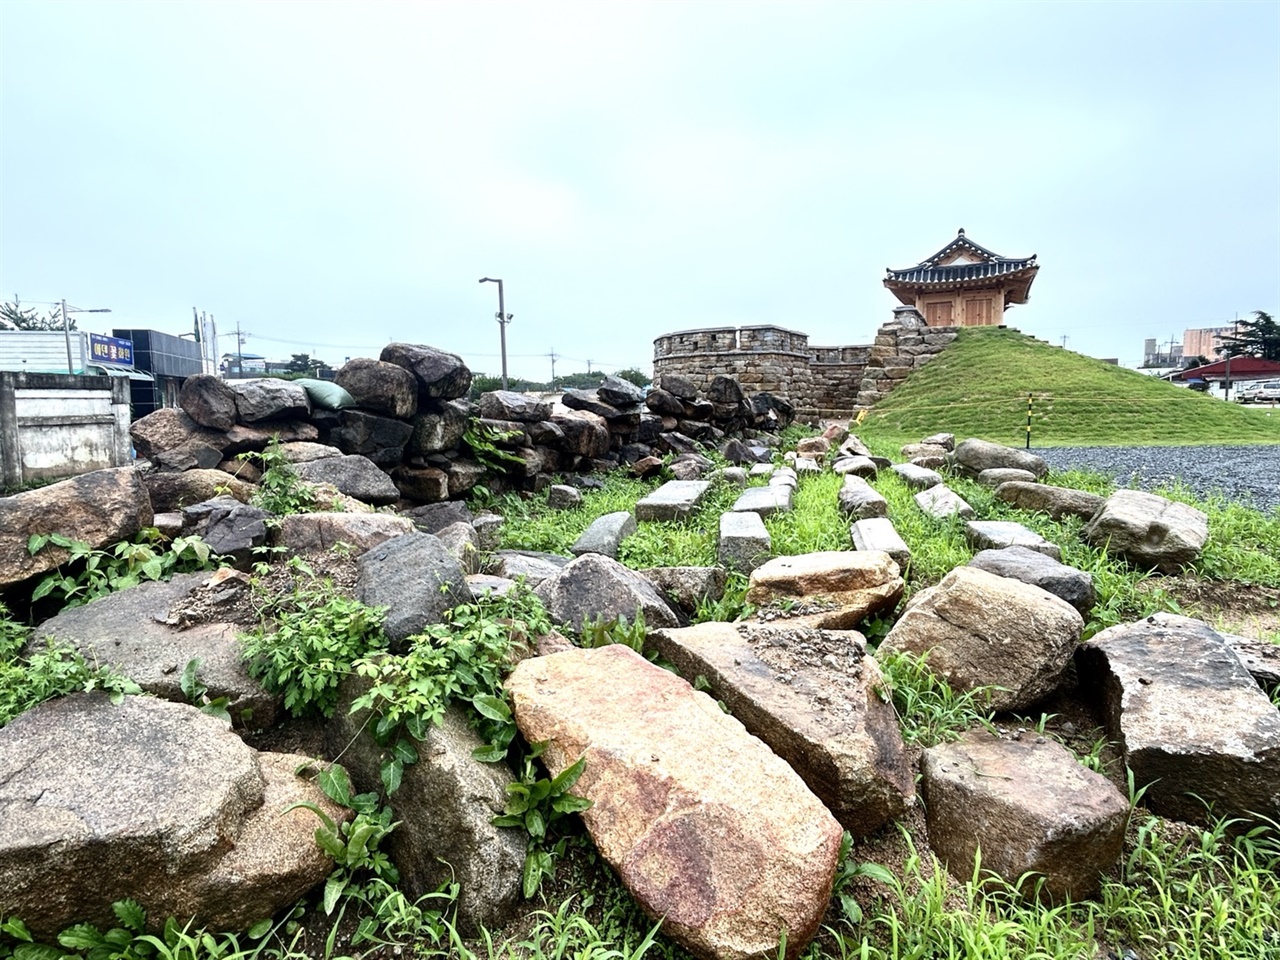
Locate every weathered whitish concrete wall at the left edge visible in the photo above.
<box><xmin>0</xmin><ymin>371</ymin><xmax>132</xmax><ymax>489</ymax></box>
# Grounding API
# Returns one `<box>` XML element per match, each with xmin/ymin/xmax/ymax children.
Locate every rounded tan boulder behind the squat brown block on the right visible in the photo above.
<box><xmin>877</xmin><ymin>567</ymin><xmax>1084</xmax><ymax>710</ymax></box>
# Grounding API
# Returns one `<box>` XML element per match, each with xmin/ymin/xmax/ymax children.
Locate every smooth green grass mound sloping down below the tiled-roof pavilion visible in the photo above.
<box><xmin>859</xmin><ymin>326</ymin><xmax>1280</xmax><ymax>449</ymax></box>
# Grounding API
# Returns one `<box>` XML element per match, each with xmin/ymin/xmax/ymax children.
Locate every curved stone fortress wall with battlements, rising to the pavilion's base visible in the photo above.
<box><xmin>653</xmin><ymin>306</ymin><xmax>956</xmax><ymax>420</ymax></box>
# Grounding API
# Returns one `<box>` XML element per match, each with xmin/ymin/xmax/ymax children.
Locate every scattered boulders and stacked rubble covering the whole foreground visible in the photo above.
<box><xmin>0</xmin><ymin>348</ymin><xmax>1280</xmax><ymax>960</ymax></box>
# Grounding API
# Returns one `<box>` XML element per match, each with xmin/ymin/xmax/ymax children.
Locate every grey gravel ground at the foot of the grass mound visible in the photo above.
<box><xmin>1032</xmin><ymin>444</ymin><xmax>1280</xmax><ymax>509</ymax></box>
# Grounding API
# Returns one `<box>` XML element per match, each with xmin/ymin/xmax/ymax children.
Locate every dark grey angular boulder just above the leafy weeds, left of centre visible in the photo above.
<box><xmin>356</xmin><ymin>532</ymin><xmax>474</xmax><ymax>644</ymax></box>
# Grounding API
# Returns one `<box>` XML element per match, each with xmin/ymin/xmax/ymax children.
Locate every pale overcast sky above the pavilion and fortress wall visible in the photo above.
<box><xmin>0</xmin><ymin>0</ymin><xmax>1280</xmax><ymax>380</ymax></box>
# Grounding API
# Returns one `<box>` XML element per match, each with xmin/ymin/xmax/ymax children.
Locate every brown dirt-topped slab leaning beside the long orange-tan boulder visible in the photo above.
<box><xmin>645</xmin><ymin>622</ymin><xmax>915</xmax><ymax>837</ymax></box>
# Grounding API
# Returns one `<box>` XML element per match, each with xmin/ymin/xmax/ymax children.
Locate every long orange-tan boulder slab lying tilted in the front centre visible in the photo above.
<box><xmin>507</xmin><ymin>644</ymin><xmax>841</xmax><ymax>960</ymax></box>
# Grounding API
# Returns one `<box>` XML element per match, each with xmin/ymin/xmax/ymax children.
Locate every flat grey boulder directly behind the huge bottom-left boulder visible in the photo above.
<box><xmin>27</xmin><ymin>573</ymin><xmax>279</xmax><ymax>727</ymax></box>
